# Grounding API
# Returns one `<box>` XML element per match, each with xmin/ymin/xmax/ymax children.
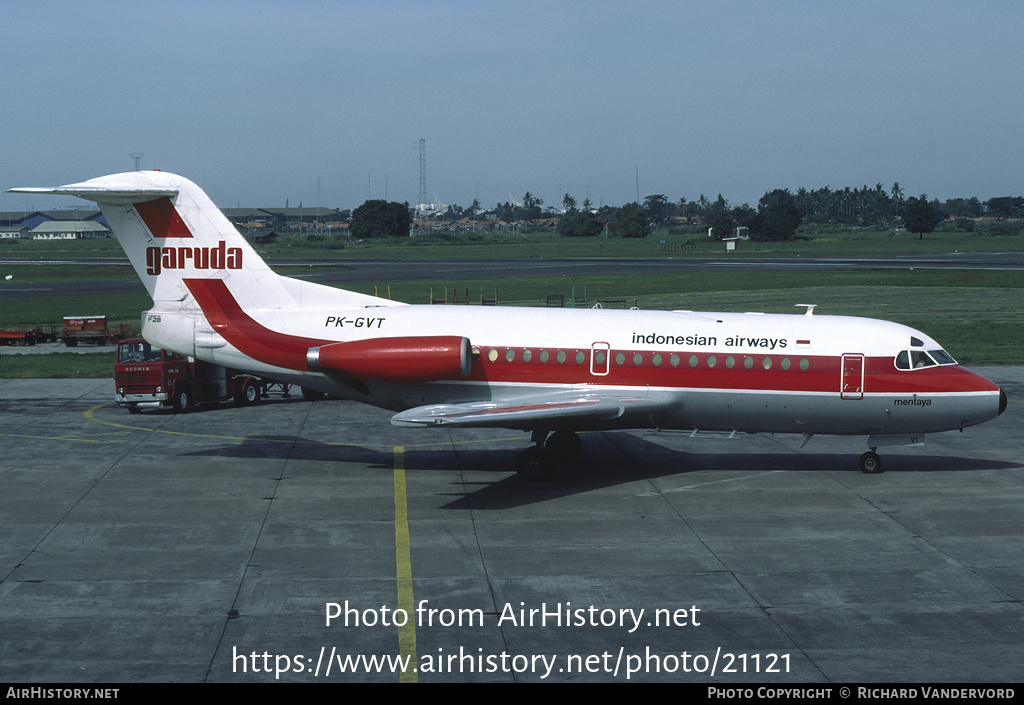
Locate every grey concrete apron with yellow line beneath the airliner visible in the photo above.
<box><xmin>0</xmin><ymin>367</ymin><xmax>1024</xmax><ymax>685</ymax></box>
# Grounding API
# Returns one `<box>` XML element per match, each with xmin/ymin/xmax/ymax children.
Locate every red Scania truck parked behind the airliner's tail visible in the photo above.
<box><xmin>114</xmin><ymin>337</ymin><xmax>268</xmax><ymax>414</ymax></box>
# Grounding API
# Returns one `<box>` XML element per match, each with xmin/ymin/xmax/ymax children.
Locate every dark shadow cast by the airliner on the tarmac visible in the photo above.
<box><xmin>176</xmin><ymin>431</ymin><xmax>1020</xmax><ymax>509</ymax></box>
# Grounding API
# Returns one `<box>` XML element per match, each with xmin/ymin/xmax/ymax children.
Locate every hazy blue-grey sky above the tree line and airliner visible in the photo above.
<box><xmin>0</xmin><ymin>0</ymin><xmax>1024</xmax><ymax>210</ymax></box>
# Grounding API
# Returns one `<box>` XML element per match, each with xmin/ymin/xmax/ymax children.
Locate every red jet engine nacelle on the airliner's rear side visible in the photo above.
<box><xmin>306</xmin><ymin>335</ymin><xmax>473</xmax><ymax>382</ymax></box>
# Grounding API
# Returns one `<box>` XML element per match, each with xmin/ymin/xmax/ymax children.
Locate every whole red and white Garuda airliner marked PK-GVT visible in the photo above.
<box><xmin>10</xmin><ymin>171</ymin><xmax>1007</xmax><ymax>480</ymax></box>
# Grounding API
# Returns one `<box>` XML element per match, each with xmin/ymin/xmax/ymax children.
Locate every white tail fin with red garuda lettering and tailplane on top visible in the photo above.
<box><xmin>11</xmin><ymin>171</ymin><xmax>394</xmax><ymax>309</ymax></box>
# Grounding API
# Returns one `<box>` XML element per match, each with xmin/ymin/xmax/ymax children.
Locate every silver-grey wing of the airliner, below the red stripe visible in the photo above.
<box><xmin>391</xmin><ymin>392</ymin><xmax>672</xmax><ymax>430</ymax></box>
